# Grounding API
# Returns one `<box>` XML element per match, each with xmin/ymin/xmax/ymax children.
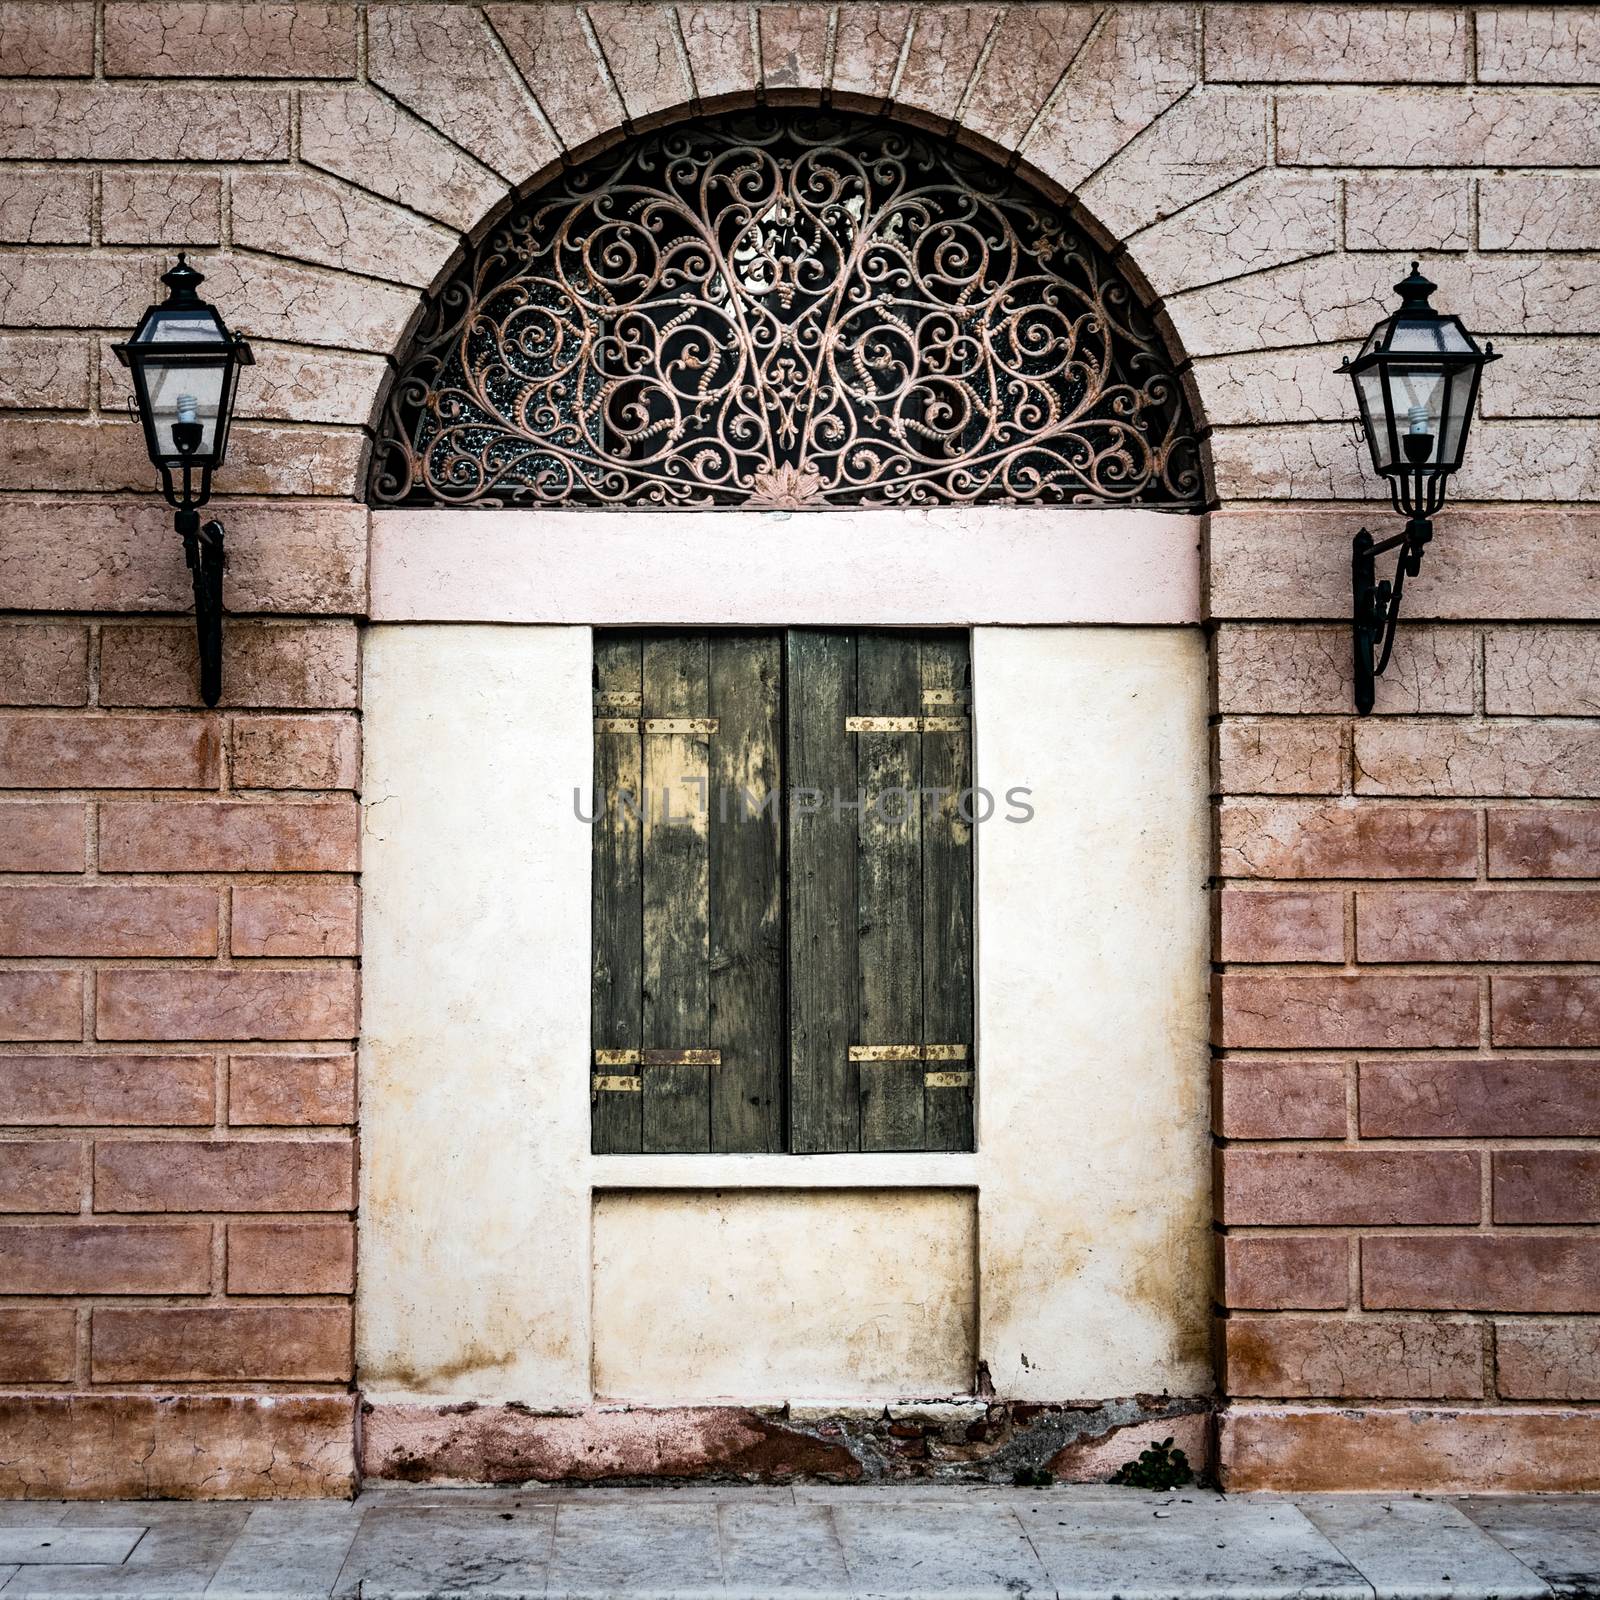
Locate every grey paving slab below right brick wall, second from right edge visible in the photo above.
<box><xmin>1294</xmin><ymin>1494</ymin><xmax>1550</xmax><ymax>1600</ymax></box>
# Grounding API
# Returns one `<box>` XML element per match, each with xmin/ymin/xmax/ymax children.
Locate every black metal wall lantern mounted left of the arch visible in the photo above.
<box><xmin>114</xmin><ymin>256</ymin><xmax>254</xmax><ymax>706</ymax></box>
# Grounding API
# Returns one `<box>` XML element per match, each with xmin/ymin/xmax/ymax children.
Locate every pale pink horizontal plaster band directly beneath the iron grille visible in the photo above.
<box><xmin>371</xmin><ymin>506</ymin><xmax>1202</xmax><ymax>627</ymax></box>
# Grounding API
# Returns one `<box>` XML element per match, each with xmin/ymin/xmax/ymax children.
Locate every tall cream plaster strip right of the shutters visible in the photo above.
<box><xmin>973</xmin><ymin>629</ymin><xmax>1211</xmax><ymax>1400</ymax></box>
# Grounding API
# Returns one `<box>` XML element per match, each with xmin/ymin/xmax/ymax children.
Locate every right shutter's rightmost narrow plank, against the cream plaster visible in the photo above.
<box><xmin>922</xmin><ymin>635</ymin><xmax>981</xmax><ymax>1150</ymax></box>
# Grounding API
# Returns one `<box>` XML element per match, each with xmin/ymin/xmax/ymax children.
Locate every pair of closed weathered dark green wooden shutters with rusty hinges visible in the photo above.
<box><xmin>592</xmin><ymin>629</ymin><xmax>974</xmax><ymax>1154</ymax></box>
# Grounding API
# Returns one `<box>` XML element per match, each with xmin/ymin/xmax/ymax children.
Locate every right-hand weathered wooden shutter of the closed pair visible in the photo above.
<box><xmin>787</xmin><ymin>630</ymin><xmax>974</xmax><ymax>1152</ymax></box>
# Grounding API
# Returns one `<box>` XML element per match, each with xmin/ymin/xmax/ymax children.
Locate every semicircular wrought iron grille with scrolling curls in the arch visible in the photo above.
<box><xmin>371</xmin><ymin>109</ymin><xmax>1202</xmax><ymax>507</ymax></box>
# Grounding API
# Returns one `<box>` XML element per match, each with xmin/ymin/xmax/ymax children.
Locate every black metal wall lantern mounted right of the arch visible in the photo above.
<box><xmin>1339</xmin><ymin>261</ymin><xmax>1499</xmax><ymax>717</ymax></box>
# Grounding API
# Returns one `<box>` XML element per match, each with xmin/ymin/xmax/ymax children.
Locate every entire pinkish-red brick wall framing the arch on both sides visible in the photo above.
<box><xmin>0</xmin><ymin>0</ymin><xmax>1600</xmax><ymax>1493</ymax></box>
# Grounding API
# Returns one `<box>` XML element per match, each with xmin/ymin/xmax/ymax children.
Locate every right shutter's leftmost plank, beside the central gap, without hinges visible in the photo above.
<box><xmin>786</xmin><ymin>629</ymin><xmax>861</xmax><ymax>1154</ymax></box>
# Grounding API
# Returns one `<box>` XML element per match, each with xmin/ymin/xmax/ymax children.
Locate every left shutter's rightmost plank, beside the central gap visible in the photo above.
<box><xmin>713</xmin><ymin>634</ymin><xmax>784</xmax><ymax>1150</ymax></box>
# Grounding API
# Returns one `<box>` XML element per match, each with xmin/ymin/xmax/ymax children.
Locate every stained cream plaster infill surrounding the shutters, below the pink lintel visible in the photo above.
<box><xmin>358</xmin><ymin>617</ymin><xmax>1211</xmax><ymax>1408</ymax></box>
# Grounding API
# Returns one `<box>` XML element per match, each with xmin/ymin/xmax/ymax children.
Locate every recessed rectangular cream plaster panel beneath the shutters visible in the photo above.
<box><xmin>594</xmin><ymin>1189</ymin><xmax>978</xmax><ymax>1403</ymax></box>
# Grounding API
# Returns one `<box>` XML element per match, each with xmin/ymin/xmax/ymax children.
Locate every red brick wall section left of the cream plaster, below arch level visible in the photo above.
<box><xmin>0</xmin><ymin>501</ymin><xmax>365</xmax><ymax>1494</ymax></box>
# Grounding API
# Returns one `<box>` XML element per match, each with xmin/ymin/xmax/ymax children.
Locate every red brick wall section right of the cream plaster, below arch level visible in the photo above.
<box><xmin>1213</xmin><ymin>508</ymin><xmax>1600</xmax><ymax>1488</ymax></box>
